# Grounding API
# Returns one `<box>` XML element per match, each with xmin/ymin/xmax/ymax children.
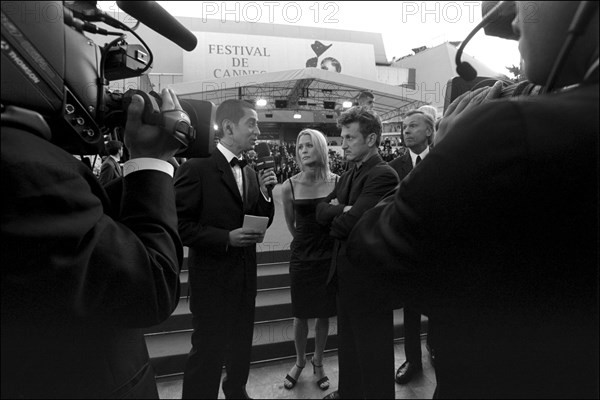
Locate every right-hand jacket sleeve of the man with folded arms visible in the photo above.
<box><xmin>329</xmin><ymin>165</ymin><xmax>398</xmax><ymax>240</ymax></box>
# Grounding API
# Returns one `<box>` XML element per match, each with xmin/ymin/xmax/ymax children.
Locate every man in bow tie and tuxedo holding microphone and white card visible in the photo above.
<box><xmin>175</xmin><ymin>100</ymin><xmax>277</xmax><ymax>399</ymax></box>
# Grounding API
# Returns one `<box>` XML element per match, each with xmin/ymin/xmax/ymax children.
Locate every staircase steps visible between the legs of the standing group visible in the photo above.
<box><xmin>145</xmin><ymin>247</ymin><xmax>427</xmax><ymax>376</ymax></box>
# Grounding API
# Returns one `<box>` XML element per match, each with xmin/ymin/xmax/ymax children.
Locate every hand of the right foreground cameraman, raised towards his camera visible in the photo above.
<box><xmin>434</xmin><ymin>81</ymin><xmax>502</xmax><ymax>145</ymax></box>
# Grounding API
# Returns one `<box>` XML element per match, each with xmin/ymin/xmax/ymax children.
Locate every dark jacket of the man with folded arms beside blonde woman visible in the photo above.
<box><xmin>317</xmin><ymin>154</ymin><xmax>398</xmax><ymax>310</ymax></box>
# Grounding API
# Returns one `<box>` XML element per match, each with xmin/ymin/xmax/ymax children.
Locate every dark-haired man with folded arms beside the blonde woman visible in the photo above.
<box><xmin>317</xmin><ymin>107</ymin><xmax>398</xmax><ymax>398</ymax></box>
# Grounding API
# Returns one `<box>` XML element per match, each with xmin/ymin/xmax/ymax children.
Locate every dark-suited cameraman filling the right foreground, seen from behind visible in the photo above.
<box><xmin>348</xmin><ymin>2</ymin><xmax>599</xmax><ymax>398</ymax></box>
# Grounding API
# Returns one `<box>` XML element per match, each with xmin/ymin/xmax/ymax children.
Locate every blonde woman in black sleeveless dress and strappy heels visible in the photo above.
<box><xmin>282</xmin><ymin>129</ymin><xmax>338</xmax><ymax>390</ymax></box>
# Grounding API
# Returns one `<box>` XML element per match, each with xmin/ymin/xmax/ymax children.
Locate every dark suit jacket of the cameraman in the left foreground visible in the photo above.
<box><xmin>0</xmin><ymin>127</ymin><xmax>183</xmax><ymax>398</ymax></box>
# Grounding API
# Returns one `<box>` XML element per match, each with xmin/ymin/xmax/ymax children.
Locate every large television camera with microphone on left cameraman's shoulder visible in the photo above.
<box><xmin>0</xmin><ymin>1</ymin><xmax>215</xmax><ymax>157</ymax></box>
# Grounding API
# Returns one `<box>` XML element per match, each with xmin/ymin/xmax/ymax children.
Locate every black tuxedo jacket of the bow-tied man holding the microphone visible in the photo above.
<box><xmin>175</xmin><ymin>150</ymin><xmax>275</xmax><ymax>312</ymax></box>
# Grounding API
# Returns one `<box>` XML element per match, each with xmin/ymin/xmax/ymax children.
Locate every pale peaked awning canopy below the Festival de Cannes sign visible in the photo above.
<box><xmin>170</xmin><ymin>68</ymin><xmax>427</xmax><ymax>121</ymax></box>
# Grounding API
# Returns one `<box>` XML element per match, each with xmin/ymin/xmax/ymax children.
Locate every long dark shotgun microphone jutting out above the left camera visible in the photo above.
<box><xmin>117</xmin><ymin>1</ymin><xmax>198</xmax><ymax>51</ymax></box>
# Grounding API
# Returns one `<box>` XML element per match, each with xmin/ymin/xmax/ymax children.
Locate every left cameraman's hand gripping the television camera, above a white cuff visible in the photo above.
<box><xmin>124</xmin><ymin>89</ymin><xmax>182</xmax><ymax>161</ymax></box>
